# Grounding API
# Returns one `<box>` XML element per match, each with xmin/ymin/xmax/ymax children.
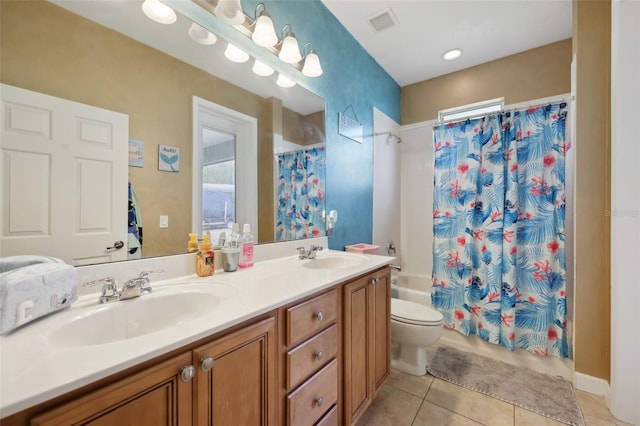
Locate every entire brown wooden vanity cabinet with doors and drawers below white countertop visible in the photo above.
<box><xmin>7</xmin><ymin>267</ymin><xmax>391</xmax><ymax>426</ymax></box>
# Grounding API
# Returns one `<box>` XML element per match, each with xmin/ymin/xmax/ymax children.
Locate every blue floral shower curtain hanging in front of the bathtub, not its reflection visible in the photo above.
<box><xmin>432</xmin><ymin>103</ymin><xmax>569</xmax><ymax>357</ymax></box>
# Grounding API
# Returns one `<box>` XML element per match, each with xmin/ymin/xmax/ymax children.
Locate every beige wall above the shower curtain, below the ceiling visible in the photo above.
<box><xmin>401</xmin><ymin>39</ymin><xmax>571</xmax><ymax>124</ymax></box>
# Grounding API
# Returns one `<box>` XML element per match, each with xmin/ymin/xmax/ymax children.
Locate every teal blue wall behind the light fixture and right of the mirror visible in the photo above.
<box><xmin>169</xmin><ymin>0</ymin><xmax>400</xmax><ymax>250</ymax></box>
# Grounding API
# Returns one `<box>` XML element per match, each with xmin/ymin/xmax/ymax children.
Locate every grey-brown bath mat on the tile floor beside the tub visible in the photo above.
<box><xmin>427</xmin><ymin>346</ymin><xmax>585</xmax><ymax>426</ymax></box>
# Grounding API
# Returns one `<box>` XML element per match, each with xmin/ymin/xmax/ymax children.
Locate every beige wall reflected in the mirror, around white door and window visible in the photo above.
<box><xmin>0</xmin><ymin>1</ymin><xmax>273</xmax><ymax>256</ymax></box>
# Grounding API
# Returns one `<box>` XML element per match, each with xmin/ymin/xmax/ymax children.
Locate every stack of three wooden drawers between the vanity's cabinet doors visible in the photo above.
<box><xmin>278</xmin><ymin>288</ymin><xmax>342</xmax><ymax>426</ymax></box>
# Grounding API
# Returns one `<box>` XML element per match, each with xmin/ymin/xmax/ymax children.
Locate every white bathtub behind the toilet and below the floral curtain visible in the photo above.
<box><xmin>391</xmin><ymin>273</ymin><xmax>573</xmax><ymax>381</ymax></box>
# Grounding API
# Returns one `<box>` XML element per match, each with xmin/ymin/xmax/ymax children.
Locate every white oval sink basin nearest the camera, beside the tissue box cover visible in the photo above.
<box><xmin>49</xmin><ymin>290</ymin><xmax>222</xmax><ymax>346</ymax></box>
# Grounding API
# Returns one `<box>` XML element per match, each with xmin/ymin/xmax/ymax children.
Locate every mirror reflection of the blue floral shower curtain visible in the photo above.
<box><xmin>276</xmin><ymin>147</ymin><xmax>325</xmax><ymax>241</ymax></box>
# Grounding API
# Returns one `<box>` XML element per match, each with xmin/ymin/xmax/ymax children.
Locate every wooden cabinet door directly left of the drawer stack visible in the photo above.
<box><xmin>193</xmin><ymin>317</ymin><xmax>277</xmax><ymax>426</ymax></box>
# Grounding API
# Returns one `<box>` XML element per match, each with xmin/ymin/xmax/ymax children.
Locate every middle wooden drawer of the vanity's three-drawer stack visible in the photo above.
<box><xmin>287</xmin><ymin>324</ymin><xmax>338</xmax><ymax>389</ymax></box>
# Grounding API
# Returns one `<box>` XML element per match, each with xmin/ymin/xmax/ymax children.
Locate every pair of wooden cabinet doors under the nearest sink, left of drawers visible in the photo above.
<box><xmin>26</xmin><ymin>316</ymin><xmax>277</xmax><ymax>426</ymax></box>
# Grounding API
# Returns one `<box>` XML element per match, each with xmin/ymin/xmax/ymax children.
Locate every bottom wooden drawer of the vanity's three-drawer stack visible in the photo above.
<box><xmin>287</xmin><ymin>359</ymin><xmax>338</xmax><ymax>426</ymax></box>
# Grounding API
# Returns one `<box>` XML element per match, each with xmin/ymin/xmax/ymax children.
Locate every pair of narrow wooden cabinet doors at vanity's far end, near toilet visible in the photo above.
<box><xmin>343</xmin><ymin>268</ymin><xmax>391</xmax><ymax>424</ymax></box>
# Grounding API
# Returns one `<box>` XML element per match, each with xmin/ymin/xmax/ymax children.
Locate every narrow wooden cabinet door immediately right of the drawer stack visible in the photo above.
<box><xmin>344</xmin><ymin>277</ymin><xmax>372</xmax><ymax>424</ymax></box>
